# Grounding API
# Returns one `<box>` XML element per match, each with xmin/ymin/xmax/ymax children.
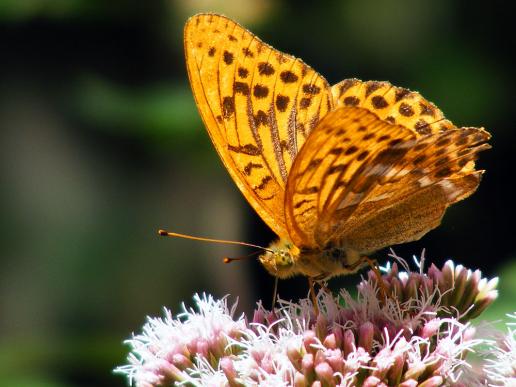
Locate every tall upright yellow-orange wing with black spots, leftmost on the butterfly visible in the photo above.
<box><xmin>185</xmin><ymin>14</ymin><xmax>332</xmax><ymax>237</ymax></box>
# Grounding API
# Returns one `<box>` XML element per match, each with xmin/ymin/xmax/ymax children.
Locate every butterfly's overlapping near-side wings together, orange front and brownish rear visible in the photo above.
<box><xmin>286</xmin><ymin>107</ymin><xmax>489</xmax><ymax>253</ymax></box>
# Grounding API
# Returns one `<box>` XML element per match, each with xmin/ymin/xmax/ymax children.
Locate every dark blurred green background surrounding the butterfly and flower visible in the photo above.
<box><xmin>0</xmin><ymin>0</ymin><xmax>516</xmax><ymax>386</ymax></box>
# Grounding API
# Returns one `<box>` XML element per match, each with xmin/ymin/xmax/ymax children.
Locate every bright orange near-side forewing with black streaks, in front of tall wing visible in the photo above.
<box><xmin>285</xmin><ymin>107</ymin><xmax>415</xmax><ymax>247</ymax></box>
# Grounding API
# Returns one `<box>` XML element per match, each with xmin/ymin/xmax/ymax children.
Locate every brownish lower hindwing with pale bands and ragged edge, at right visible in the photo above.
<box><xmin>331</xmin><ymin>128</ymin><xmax>490</xmax><ymax>252</ymax></box>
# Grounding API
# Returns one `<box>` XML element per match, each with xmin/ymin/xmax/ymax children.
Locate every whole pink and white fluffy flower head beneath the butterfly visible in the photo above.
<box><xmin>115</xmin><ymin>254</ymin><xmax>506</xmax><ymax>387</ymax></box>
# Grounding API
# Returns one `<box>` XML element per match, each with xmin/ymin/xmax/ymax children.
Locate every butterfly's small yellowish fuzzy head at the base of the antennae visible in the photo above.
<box><xmin>260</xmin><ymin>239</ymin><xmax>299</xmax><ymax>278</ymax></box>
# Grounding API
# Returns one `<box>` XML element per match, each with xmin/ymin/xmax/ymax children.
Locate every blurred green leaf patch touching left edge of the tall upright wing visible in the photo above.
<box><xmin>70</xmin><ymin>77</ymin><xmax>208</xmax><ymax>154</ymax></box>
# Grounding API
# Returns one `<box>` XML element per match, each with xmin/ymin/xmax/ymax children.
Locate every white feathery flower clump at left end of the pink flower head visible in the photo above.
<box><xmin>116</xmin><ymin>295</ymin><xmax>247</xmax><ymax>386</ymax></box>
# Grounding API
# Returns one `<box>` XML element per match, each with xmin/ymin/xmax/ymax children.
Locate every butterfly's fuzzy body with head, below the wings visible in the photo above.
<box><xmin>260</xmin><ymin>239</ymin><xmax>364</xmax><ymax>280</ymax></box>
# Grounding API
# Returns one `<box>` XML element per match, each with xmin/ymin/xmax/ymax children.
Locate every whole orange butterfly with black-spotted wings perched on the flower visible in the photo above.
<box><xmin>184</xmin><ymin>14</ymin><xmax>490</xmax><ymax>280</ymax></box>
